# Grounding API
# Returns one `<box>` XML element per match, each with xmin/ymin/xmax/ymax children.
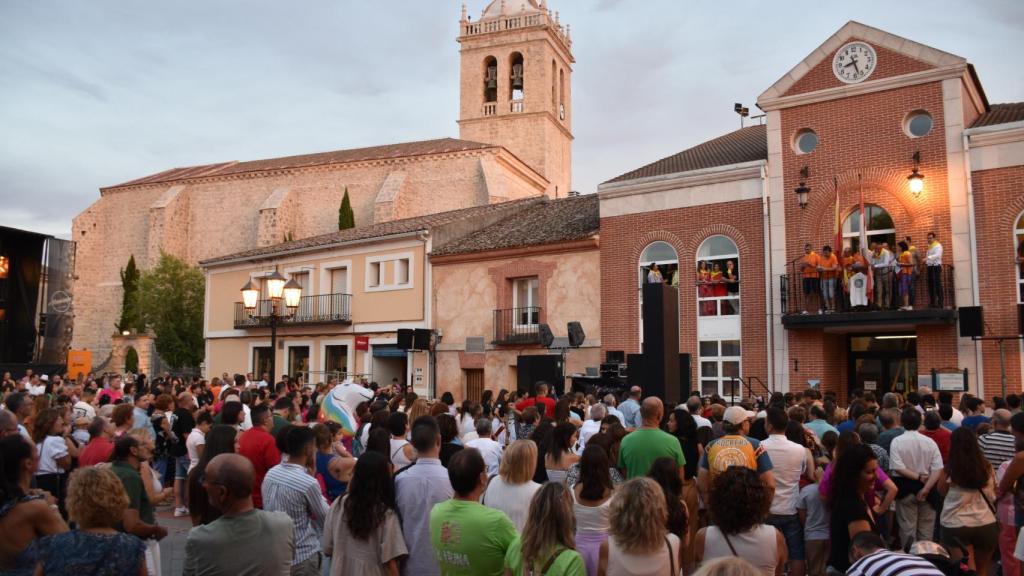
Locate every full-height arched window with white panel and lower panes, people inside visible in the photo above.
<box><xmin>694</xmin><ymin>235</ymin><xmax>743</xmax><ymax>398</ymax></box>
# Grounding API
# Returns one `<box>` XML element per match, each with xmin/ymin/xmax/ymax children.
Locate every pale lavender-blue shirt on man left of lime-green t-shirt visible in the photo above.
<box><xmin>394</xmin><ymin>457</ymin><xmax>455</xmax><ymax>576</ymax></box>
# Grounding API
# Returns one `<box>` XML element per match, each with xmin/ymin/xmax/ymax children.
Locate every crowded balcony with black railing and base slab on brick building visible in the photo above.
<box><xmin>779</xmin><ymin>264</ymin><xmax>956</xmax><ymax>329</ymax></box>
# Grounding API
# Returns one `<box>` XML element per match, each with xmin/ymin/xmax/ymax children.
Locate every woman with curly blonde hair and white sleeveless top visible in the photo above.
<box><xmin>597</xmin><ymin>478</ymin><xmax>682</xmax><ymax>576</ymax></box>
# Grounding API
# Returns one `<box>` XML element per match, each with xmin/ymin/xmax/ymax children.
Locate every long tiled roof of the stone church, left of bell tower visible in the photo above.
<box><xmin>108</xmin><ymin>138</ymin><xmax>495</xmax><ymax>188</ymax></box>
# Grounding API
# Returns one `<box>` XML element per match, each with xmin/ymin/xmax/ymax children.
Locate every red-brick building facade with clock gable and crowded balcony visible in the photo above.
<box><xmin>599</xmin><ymin>22</ymin><xmax>1024</xmax><ymax>399</ymax></box>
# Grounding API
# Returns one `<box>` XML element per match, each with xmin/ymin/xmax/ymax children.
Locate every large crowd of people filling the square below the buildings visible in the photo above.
<box><xmin>0</xmin><ymin>364</ymin><xmax>1024</xmax><ymax>576</ymax></box>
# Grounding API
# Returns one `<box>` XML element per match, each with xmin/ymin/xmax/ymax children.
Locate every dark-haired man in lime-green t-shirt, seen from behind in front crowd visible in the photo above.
<box><xmin>430</xmin><ymin>448</ymin><xmax>517</xmax><ymax>576</ymax></box>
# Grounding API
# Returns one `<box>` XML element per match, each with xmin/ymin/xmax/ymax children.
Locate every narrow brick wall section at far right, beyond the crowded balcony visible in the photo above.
<box><xmin>972</xmin><ymin>166</ymin><xmax>1024</xmax><ymax>398</ymax></box>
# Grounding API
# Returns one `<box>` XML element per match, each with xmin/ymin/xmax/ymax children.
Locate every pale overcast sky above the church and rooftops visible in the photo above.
<box><xmin>0</xmin><ymin>0</ymin><xmax>1024</xmax><ymax>237</ymax></box>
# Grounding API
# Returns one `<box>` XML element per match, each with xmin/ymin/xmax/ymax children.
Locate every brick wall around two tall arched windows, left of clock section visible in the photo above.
<box><xmin>601</xmin><ymin>195</ymin><xmax>768</xmax><ymax>386</ymax></box>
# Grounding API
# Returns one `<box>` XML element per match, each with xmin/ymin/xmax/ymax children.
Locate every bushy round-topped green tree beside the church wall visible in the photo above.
<box><xmin>139</xmin><ymin>252</ymin><xmax>206</xmax><ymax>369</ymax></box>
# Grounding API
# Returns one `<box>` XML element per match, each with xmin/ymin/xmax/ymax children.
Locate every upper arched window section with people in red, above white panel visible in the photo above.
<box><xmin>696</xmin><ymin>236</ymin><xmax>739</xmax><ymax>316</ymax></box>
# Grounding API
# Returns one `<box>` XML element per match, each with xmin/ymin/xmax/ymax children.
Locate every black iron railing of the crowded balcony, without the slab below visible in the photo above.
<box><xmin>779</xmin><ymin>264</ymin><xmax>956</xmax><ymax>315</ymax></box>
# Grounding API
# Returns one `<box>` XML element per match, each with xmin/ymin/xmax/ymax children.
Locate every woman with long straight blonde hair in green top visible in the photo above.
<box><xmin>505</xmin><ymin>479</ymin><xmax>587</xmax><ymax>576</ymax></box>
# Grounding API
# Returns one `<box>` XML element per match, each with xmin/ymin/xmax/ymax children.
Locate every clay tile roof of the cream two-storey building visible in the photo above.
<box><xmin>194</xmin><ymin>197</ymin><xmax>541</xmax><ymax>265</ymax></box>
